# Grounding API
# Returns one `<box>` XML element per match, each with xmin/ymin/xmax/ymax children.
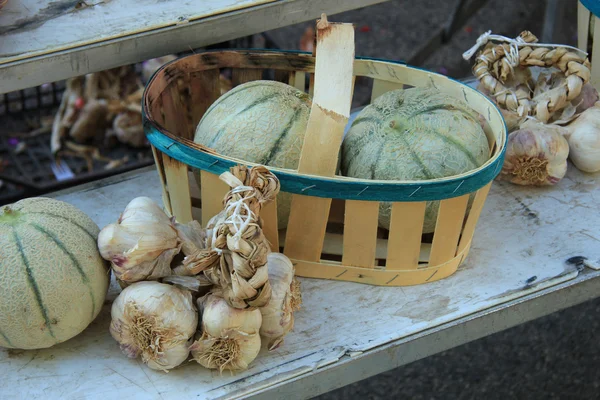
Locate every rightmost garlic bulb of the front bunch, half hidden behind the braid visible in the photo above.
<box><xmin>260</xmin><ymin>253</ymin><xmax>302</xmax><ymax>350</ymax></box>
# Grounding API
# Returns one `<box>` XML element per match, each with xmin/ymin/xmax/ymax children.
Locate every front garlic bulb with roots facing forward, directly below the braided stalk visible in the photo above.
<box><xmin>190</xmin><ymin>294</ymin><xmax>262</xmax><ymax>372</ymax></box>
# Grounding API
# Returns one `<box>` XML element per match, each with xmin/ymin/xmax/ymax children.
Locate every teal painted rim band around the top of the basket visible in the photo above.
<box><xmin>142</xmin><ymin>49</ymin><xmax>507</xmax><ymax>202</ymax></box>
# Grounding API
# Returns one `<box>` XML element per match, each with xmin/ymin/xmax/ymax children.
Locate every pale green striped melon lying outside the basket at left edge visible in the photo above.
<box><xmin>0</xmin><ymin>197</ymin><xmax>110</xmax><ymax>349</ymax></box>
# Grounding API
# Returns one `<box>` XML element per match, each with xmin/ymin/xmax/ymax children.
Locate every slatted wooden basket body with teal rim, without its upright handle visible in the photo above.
<box><xmin>143</xmin><ymin>50</ymin><xmax>507</xmax><ymax>286</ymax></box>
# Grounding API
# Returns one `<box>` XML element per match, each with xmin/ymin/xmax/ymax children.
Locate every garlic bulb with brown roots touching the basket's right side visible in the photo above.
<box><xmin>499</xmin><ymin>121</ymin><xmax>569</xmax><ymax>186</ymax></box>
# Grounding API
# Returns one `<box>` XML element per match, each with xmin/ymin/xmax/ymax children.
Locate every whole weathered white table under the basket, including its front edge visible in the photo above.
<box><xmin>0</xmin><ymin>166</ymin><xmax>600</xmax><ymax>399</ymax></box>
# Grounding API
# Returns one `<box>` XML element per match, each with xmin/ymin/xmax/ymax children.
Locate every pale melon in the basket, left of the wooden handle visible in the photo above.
<box><xmin>194</xmin><ymin>80</ymin><xmax>311</xmax><ymax>228</ymax></box>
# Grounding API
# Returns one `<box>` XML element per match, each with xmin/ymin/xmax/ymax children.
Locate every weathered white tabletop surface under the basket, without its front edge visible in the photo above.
<box><xmin>0</xmin><ymin>166</ymin><xmax>600</xmax><ymax>399</ymax></box>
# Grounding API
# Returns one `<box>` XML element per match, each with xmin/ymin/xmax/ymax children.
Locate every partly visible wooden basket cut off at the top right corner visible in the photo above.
<box><xmin>577</xmin><ymin>0</ymin><xmax>600</xmax><ymax>91</ymax></box>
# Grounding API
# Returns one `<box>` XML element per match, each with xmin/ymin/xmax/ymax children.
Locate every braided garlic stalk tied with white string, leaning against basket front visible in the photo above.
<box><xmin>180</xmin><ymin>166</ymin><xmax>279</xmax><ymax>308</ymax></box>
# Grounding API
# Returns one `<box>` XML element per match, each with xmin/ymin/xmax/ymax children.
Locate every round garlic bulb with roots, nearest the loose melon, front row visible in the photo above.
<box><xmin>110</xmin><ymin>281</ymin><xmax>198</xmax><ymax>372</ymax></box>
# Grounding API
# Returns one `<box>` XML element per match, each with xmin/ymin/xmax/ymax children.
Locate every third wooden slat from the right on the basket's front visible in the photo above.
<box><xmin>385</xmin><ymin>201</ymin><xmax>427</xmax><ymax>270</ymax></box>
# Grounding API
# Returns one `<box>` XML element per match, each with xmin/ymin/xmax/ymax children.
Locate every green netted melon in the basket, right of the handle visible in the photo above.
<box><xmin>342</xmin><ymin>88</ymin><xmax>489</xmax><ymax>233</ymax></box>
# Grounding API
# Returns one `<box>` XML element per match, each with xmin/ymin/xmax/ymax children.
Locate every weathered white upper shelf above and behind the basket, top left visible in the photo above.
<box><xmin>0</xmin><ymin>0</ymin><xmax>385</xmax><ymax>93</ymax></box>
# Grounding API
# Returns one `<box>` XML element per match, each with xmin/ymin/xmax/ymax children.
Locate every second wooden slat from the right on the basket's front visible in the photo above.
<box><xmin>429</xmin><ymin>194</ymin><xmax>469</xmax><ymax>267</ymax></box>
